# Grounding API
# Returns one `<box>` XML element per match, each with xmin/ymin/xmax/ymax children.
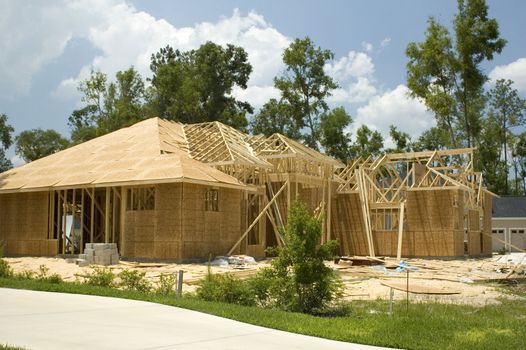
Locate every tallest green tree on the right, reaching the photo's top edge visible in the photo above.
<box><xmin>406</xmin><ymin>0</ymin><xmax>506</xmax><ymax>147</ymax></box>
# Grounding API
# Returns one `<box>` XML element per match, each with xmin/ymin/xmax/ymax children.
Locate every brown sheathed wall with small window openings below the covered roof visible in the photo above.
<box><xmin>121</xmin><ymin>183</ymin><xmax>245</xmax><ymax>260</ymax></box>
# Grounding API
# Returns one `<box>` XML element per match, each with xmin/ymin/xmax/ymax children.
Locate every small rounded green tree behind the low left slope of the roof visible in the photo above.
<box><xmin>15</xmin><ymin>129</ymin><xmax>69</xmax><ymax>162</ymax></box>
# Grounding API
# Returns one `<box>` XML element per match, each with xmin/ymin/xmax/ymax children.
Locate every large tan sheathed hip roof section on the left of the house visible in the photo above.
<box><xmin>0</xmin><ymin>118</ymin><xmax>244</xmax><ymax>192</ymax></box>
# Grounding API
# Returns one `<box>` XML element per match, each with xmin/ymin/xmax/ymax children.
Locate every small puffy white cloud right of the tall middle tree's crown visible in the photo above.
<box><xmin>324</xmin><ymin>51</ymin><xmax>374</xmax><ymax>81</ymax></box>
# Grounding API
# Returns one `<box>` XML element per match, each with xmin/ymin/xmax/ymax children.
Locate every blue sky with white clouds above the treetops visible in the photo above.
<box><xmin>0</xmin><ymin>0</ymin><xmax>526</xmax><ymax>163</ymax></box>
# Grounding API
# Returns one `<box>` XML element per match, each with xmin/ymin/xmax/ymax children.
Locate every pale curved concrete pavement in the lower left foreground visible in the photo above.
<box><xmin>0</xmin><ymin>288</ymin><xmax>392</xmax><ymax>350</ymax></box>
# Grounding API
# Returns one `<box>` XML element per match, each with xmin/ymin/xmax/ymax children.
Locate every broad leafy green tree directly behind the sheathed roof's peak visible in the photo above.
<box><xmin>148</xmin><ymin>42</ymin><xmax>253</xmax><ymax>130</ymax></box>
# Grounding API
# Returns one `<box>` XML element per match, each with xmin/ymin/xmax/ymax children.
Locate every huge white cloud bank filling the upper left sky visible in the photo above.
<box><xmin>0</xmin><ymin>0</ymin><xmax>290</xmax><ymax>98</ymax></box>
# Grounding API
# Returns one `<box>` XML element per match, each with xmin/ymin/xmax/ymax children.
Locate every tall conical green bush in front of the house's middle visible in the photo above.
<box><xmin>253</xmin><ymin>201</ymin><xmax>343</xmax><ymax>314</ymax></box>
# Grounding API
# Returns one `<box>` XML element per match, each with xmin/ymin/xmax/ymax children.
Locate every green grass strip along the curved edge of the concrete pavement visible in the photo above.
<box><xmin>0</xmin><ymin>278</ymin><xmax>526</xmax><ymax>350</ymax></box>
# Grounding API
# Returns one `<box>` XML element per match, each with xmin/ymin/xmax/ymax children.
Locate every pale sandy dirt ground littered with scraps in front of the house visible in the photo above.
<box><xmin>4</xmin><ymin>255</ymin><xmax>526</xmax><ymax>306</ymax></box>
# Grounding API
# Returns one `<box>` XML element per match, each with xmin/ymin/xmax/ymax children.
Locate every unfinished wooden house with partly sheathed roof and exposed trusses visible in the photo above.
<box><xmin>0</xmin><ymin>118</ymin><xmax>491</xmax><ymax>260</ymax></box>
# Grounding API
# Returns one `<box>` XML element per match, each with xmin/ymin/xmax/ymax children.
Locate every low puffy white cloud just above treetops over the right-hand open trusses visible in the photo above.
<box><xmin>351</xmin><ymin>84</ymin><xmax>435</xmax><ymax>145</ymax></box>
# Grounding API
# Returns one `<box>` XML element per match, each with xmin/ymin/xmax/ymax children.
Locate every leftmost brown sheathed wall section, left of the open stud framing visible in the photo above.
<box><xmin>0</xmin><ymin>192</ymin><xmax>58</xmax><ymax>256</ymax></box>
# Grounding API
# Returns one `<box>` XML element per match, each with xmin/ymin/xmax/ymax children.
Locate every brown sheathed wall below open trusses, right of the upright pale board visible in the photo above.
<box><xmin>404</xmin><ymin>189</ymin><xmax>464</xmax><ymax>256</ymax></box>
